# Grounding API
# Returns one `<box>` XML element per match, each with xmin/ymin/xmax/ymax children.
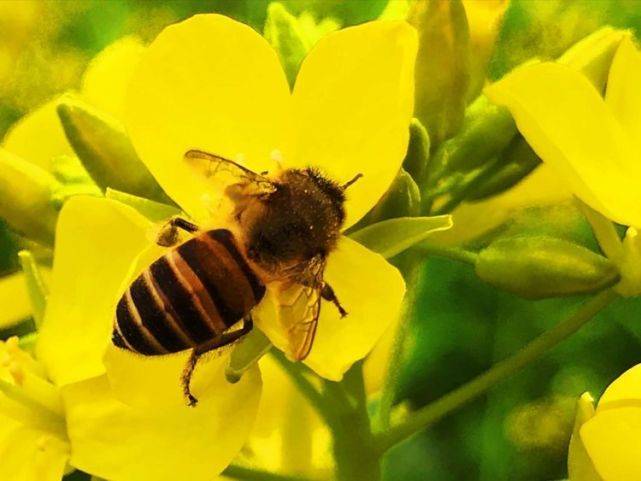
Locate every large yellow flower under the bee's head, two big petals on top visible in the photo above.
<box><xmin>125</xmin><ymin>15</ymin><xmax>416</xmax><ymax>380</ymax></box>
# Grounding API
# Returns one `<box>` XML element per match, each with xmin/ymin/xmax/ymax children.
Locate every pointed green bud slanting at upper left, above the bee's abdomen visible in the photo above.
<box><xmin>58</xmin><ymin>97</ymin><xmax>171</xmax><ymax>203</ymax></box>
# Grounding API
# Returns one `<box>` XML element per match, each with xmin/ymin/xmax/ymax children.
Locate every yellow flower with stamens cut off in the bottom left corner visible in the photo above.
<box><xmin>0</xmin><ymin>337</ymin><xmax>69</xmax><ymax>481</ymax></box>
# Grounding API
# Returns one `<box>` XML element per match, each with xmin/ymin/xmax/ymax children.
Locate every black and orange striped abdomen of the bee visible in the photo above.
<box><xmin>113</xmin><ymin>229</ymin><xmax>265</xmax><ymax>355</ymax></box>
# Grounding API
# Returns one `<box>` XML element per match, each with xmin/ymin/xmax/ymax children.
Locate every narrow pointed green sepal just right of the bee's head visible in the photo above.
<box><xmin>350</xmin><ymin>215</ymin><xmax>452</xmax><ymax>258</ymax></box>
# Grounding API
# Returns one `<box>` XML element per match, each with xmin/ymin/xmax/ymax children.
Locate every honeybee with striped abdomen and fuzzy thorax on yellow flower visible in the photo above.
<box><xmin>112</xmin><ymin>150</ymin><xmax>361</xmax><ymax>406</ymax></box>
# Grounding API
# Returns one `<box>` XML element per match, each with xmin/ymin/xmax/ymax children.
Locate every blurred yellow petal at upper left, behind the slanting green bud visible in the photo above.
<box><xmin>81</xmin><ymin>36</ymin><xmax>145</xmax><ymax>119</ymax></box>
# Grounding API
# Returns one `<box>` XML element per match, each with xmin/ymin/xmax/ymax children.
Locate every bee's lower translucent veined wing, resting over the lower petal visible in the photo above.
<box><xmin>280</xmin><ymin>260</ymin><xmax>325</xmax><ymax>361</ymax></box>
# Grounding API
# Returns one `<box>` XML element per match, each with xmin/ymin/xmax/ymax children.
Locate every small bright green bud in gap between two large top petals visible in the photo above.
<box><xmin>263</xmin><ymin>2</ymin><xmax>309</xmax><ymax>86</ymax></box>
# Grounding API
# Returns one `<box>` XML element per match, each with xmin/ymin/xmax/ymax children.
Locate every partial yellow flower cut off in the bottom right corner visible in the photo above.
<box><xmin>569</xmin><ymin>365</ymin><xmax>641</xmax><ymax>481</ymax></box>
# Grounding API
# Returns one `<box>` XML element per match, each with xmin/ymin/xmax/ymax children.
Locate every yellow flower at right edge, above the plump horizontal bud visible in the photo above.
<box><xmin>486</xmin><ymin>35</ymin><xmax>641</xmax><ymax>295</ymax></box>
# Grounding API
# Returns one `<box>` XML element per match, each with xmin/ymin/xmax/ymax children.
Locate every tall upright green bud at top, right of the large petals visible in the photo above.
<box><xmin>408</xmin><ymin>0</ymin><xmax>470</xmax><ymax>144</ymax></box>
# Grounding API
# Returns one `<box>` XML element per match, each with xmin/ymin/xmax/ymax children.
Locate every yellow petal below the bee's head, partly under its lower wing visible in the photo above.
<box><xmin>255</xmin><ymin>237</ymin><xmax>405</xmax><ymax>381</ymax></box>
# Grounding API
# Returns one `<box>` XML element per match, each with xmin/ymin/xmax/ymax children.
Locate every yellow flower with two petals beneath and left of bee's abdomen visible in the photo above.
<box><xmin>36</xmin><ymin>197</ymin><xmax>261</xmax><ymax>481</ymax></box>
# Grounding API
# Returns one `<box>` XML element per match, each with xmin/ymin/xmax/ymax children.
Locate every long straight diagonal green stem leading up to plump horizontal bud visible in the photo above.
<box><xmin>375</xmin><ymin>289</ymin><xmax>618</xmax><ymax>453</ymax></box>
